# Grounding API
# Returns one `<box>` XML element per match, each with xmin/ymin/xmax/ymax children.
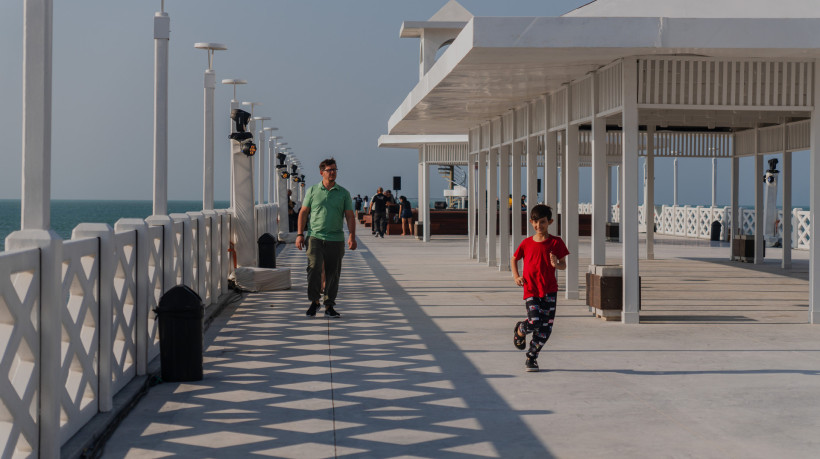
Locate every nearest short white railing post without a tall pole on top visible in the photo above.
<box><xmin>71</xmin><ymin>223</ymin><xmax>116</xmax><ymax>412</ymax></box>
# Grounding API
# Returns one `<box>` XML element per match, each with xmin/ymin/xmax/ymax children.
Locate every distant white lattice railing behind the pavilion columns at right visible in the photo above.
<box><xmin>592</xmin><ymin>203</ymin><xmax>811</xmax><ymax>250</ymax></box>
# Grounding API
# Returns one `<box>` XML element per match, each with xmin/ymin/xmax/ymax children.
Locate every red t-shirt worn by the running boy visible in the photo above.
<box><xmin>513</xmin><ymin>235</ymin><xmax>569</xmax><ymax>299</ymax></box>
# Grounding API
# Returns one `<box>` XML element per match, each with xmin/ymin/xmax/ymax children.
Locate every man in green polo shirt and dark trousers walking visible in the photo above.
<box><xmin>296</xmin><ymin>158</ymin><xmax>356</xmax><ymax>318</ymax></box>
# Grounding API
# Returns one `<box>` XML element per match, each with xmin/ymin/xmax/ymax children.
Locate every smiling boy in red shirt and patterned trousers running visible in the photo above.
<box><xmin>510</xmin><ymin>204</ymin><xmax>569</xmax><ymax>371</ymax></box>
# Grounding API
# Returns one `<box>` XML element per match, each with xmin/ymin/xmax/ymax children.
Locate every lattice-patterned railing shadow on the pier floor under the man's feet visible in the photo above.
<box><xmin>99</xmin><ymin>239</ymin><xmax>553</xmax><ymax>459</ymax></box>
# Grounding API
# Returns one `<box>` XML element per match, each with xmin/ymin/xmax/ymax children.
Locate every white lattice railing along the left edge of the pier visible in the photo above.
<box><xmin>0</xmin><ymin>205</ymin><xmax>294</xmax><ymax>457</ymax></box>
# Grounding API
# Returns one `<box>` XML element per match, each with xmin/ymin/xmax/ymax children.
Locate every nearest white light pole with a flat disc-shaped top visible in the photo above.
<box><xmin>194</xmin><ymin>43</ymin><xmax>228</xmax><ymax>210</ymax></box>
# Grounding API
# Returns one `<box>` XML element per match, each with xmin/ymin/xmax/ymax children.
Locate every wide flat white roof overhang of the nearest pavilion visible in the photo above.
<box><xmin>388</xmin><ymin>17</ymin><xmax>820</xmax><ymax>135</ymax></box>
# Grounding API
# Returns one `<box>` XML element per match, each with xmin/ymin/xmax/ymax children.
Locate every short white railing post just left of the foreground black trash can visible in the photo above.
<box><xmin>114</xmin><ymin>218</ymin><xmax>151</xmax><ymax>375</ymax></box>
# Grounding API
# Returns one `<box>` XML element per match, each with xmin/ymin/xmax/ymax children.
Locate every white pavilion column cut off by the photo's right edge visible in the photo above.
<box><xmin>809</xmin><ymin>60</ymin><xmax>820</xmax><ymax>324</ymax></box>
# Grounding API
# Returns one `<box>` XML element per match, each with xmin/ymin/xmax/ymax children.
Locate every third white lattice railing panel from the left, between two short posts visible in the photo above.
<box><xmin>111</xmin><ymin>231</ymin><xmax>137</xmax><ymax>394</ymax></box>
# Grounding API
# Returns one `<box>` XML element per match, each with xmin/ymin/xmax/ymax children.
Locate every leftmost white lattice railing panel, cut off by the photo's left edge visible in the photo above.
<box><xmin>0</xmin><ymin>249</ymin><xmax>40</xmax><ymax>457</ymax></box>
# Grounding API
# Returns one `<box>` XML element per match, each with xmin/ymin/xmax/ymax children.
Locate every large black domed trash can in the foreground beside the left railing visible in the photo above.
<box><xmin>154</xmin><ymin>285</ymin><xmax>205</xmax><ymax>382</ymax></box>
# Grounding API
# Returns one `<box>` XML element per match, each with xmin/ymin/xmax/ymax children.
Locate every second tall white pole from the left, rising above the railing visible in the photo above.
<box><xmin>153</xmin><ymin>11</ymin><xmax>171</xmax><ymax>215</ymax></box>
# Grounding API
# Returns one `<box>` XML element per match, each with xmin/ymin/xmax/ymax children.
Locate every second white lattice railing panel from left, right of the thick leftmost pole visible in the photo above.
<box><xmin>60</xmin><ymin>238</ymin><xmax>100</xmax><ymax>443</ymax></box>
